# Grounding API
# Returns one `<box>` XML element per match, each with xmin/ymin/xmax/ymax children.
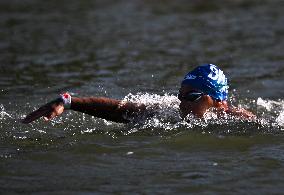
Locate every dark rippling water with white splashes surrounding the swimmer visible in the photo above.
<box><xmin>0</xmin><ymin>0</ymin><xmax>284</xmax><ymax>194</ymax></box>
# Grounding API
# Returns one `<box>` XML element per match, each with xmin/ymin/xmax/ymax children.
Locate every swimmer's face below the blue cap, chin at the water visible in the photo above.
<box><xmin>179</xmin><ymin>85</ymin><xmax>218</xmax><ymax>118</ymax></box>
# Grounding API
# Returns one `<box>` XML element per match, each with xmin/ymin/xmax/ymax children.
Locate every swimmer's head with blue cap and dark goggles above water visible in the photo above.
<box><xmin>178</xmin><ymin>64</ymin><xmax>229</xmax><ymax>118</ymax></box>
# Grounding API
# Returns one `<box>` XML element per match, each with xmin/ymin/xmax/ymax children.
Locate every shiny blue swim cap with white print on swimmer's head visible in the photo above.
<box><xmin>181</xmin><ymin>64</ymin><xmax>229</xmax><ymax>101</ymax></box>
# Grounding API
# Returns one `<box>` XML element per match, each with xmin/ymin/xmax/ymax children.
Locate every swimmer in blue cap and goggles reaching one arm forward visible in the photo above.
<box><xmin>22</xmin><ymin>64</ymin><xmax>256</xmax><ymax>124</ymax></box>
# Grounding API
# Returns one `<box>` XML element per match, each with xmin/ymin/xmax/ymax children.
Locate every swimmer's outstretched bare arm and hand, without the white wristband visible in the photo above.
<box><xmin>22</xmin><ymin>97</ymin><xmax>146</xmax><ymax>124</ymax></box>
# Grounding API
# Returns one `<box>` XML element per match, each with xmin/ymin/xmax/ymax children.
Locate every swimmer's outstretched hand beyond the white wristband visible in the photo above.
<box><xmin>21</xmin><ymin>98</ymin><xmax>64</xmax><ymax>124</ymax></box>
